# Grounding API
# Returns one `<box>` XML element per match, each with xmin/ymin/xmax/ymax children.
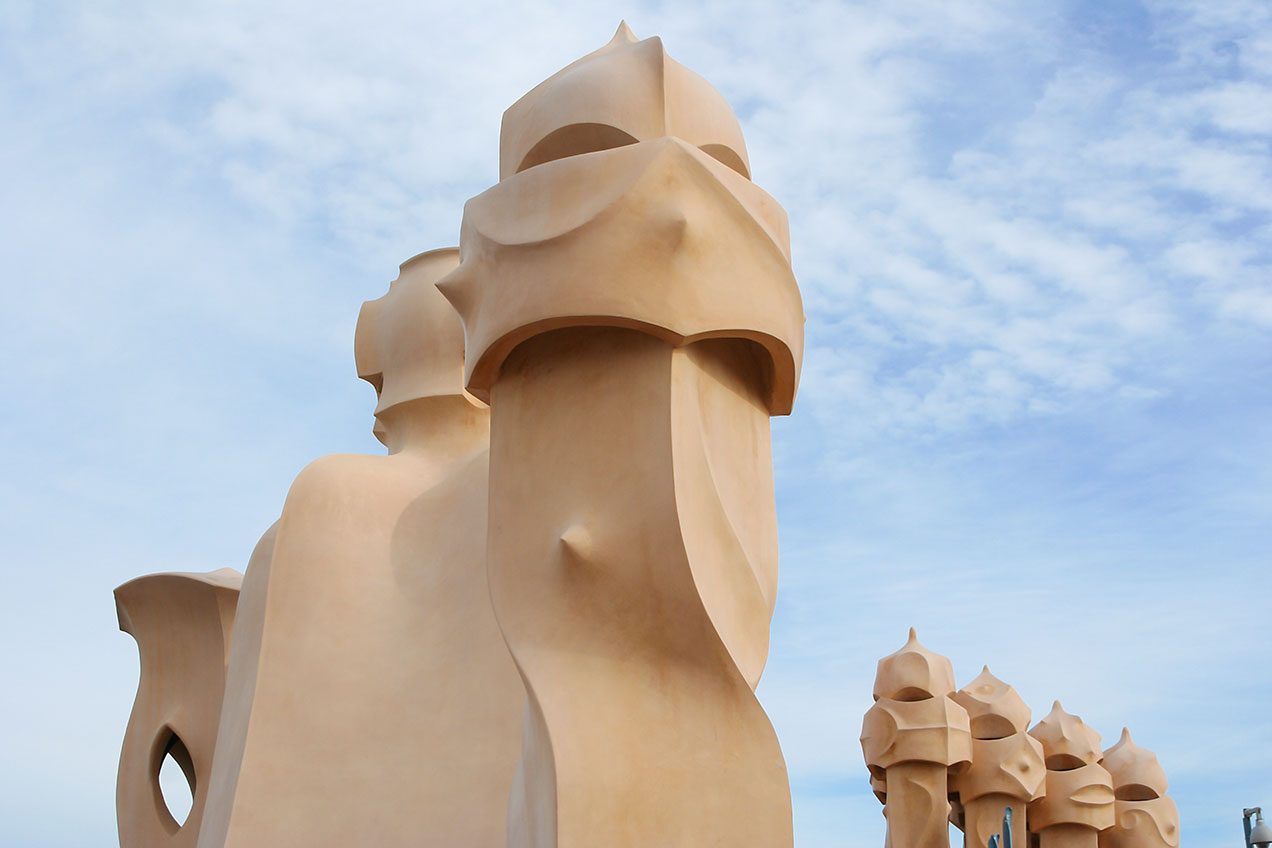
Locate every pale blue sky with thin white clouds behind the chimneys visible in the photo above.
<box><xmin>0</xmin><ymin>0</ymin><xmax>1272</xmax><ymax>848</ymax></box>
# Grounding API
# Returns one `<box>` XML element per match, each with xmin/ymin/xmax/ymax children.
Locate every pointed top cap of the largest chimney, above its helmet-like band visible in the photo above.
<box><xmin>499</xmin><ymin>23</ymin><xmax>750</xmax><ymax>179</ymax></box>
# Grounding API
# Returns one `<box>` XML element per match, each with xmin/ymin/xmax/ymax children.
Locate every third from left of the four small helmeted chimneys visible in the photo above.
<box><xmin>1029</xmin><ymin>701</ymin><xmax>1113</xmax><ymax>848</ymax></box>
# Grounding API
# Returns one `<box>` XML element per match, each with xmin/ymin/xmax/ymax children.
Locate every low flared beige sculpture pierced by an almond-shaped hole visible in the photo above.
<box><xmin>114</xmin><ymin>568</ymin><xmax>243</xmax><ymax>848</ymax></box>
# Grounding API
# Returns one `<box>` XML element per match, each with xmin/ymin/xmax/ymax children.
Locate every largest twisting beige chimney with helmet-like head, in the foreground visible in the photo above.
<box><xmin>439</xmin><ymin>24</ymin><xmax>804</xmax><ymax>848</ymax></box>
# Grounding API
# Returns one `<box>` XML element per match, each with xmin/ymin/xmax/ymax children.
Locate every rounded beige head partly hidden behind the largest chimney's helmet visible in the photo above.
<box><xmin>354</xmin><ymin>248</ymin><xmax>466</xmax><ymax>416</ymax></box>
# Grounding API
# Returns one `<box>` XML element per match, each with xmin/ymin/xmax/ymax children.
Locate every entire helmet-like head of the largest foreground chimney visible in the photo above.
<box><xmin>438</xmin><ymin>27</ymin><xmax>804</xmax><ymax>414</ymax></box>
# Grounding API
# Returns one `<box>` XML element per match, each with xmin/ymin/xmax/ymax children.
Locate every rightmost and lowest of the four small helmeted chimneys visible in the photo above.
<box><xmin>1099</xmin><ymin>727</ymin><xmax>1179</xmax><ymax>848</ymax></box>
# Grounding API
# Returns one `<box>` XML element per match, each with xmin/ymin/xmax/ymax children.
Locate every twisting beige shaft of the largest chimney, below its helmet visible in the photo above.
<box><xmin>490</xmin><ymin>328</ymin><xmax>791</xmax><ymax>847</ymax></box>
